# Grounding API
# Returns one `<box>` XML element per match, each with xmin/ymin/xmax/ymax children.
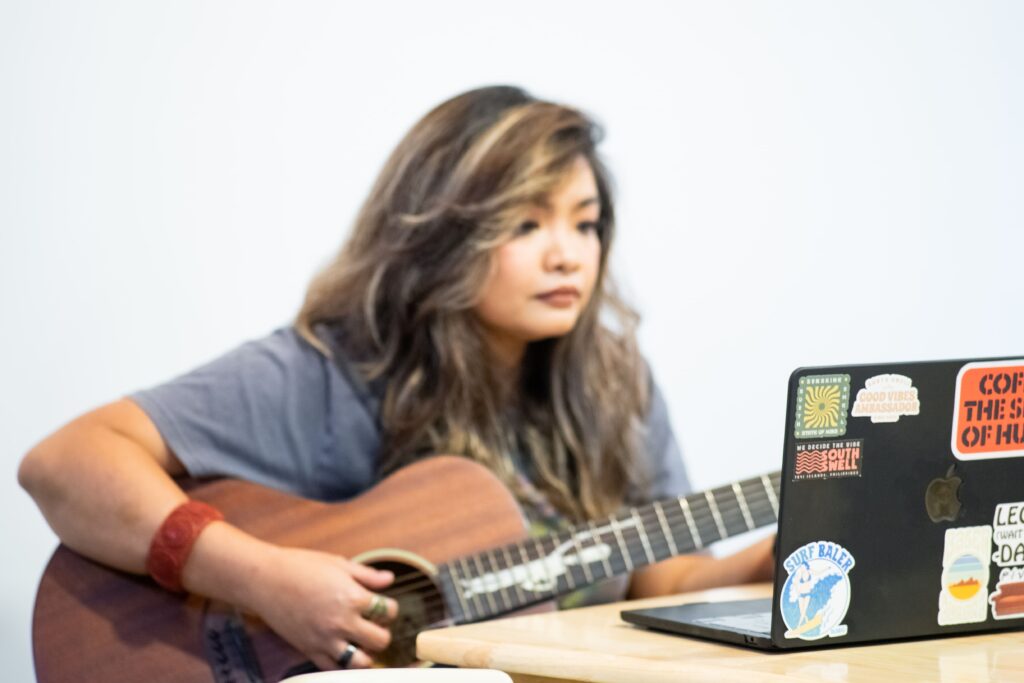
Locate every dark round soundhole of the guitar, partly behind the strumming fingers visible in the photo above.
<box><xmin>368</xmin><ymin>561</ymin><xmax>447</xmax><ymax>667</ymax></box>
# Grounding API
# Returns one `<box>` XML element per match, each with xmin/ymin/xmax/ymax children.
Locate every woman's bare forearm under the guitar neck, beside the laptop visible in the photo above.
<box><xmin>629</xmin><ymin>536</ymin><xmax>775</xmax><ymax>599</ymax></box>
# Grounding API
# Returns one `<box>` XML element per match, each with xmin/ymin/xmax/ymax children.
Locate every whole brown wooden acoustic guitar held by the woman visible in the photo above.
<box><xmin>33</xmin><ymin>456</ymin><xmax>779</xmax><ymax>683</ymax></box>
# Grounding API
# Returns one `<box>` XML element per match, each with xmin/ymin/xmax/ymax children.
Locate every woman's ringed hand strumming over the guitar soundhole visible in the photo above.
<box><xmin>247</xmin><ymin>546</ymin><xmax>398</xmax><ymax>671</ymax></box>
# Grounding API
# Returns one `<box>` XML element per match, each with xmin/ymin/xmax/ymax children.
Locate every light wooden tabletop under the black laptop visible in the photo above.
<box><xmin>417</xmin><ymin>584</ymin><xmax>1024</xmax><ymax>683</ymax></box>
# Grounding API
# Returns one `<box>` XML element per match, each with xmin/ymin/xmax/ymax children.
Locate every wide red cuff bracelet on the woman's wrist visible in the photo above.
<box><xmin>145</xmin><ymin>501</ymin><xmax>224</xmax><ymax>593</ymax></box>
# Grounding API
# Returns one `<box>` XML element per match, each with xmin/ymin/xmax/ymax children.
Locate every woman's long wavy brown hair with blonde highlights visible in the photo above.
<box><xmin>296</xmin><ymin>86</ymin><xmax>649</xmax><ymax>519</ymax></box>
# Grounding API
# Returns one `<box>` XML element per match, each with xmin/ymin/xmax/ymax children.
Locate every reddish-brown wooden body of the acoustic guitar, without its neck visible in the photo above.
<box><xmin>33</xmin><ymin>457</ymin><xmax>526</xmax><ymax>683</ymax></box>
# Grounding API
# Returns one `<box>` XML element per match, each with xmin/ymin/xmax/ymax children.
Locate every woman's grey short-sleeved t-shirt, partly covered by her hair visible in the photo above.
<box><xmin>129</xmin><ymin>327</ymin><xmax>690</xmax><ymax>503</ymax></box>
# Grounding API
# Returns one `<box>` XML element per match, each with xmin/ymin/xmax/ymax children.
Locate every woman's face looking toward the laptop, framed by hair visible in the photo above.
<box><xmin>475</xmin><ymin>157</ymin><xmax>601</xmax><ymax>365</ymax></box>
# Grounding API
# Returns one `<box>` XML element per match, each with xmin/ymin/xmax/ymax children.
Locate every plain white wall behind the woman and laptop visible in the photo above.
<box><xmin>0</xmin><ymin>0</ymin><xmax>1024</xmax><ymax>680</ymax></box>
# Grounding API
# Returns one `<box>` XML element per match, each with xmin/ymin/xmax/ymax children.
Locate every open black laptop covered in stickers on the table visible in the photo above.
<box><xmin>622</xmin><ymin>358</ymin><xmax>1024</xmax><ymax>650</ymax></box>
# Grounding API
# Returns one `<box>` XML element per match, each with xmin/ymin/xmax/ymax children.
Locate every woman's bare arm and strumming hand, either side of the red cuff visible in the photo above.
<box><xmin>18</xmin><ymin>399</ymin><xmax>396</xmax><ymax>669</ymax></box>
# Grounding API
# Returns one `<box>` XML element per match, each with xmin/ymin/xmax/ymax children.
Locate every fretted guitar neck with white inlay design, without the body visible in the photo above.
<box><xmin>438</xmin><ymin>472</ymin><xmax>779</xmax><ymax>624</ymax></box>
